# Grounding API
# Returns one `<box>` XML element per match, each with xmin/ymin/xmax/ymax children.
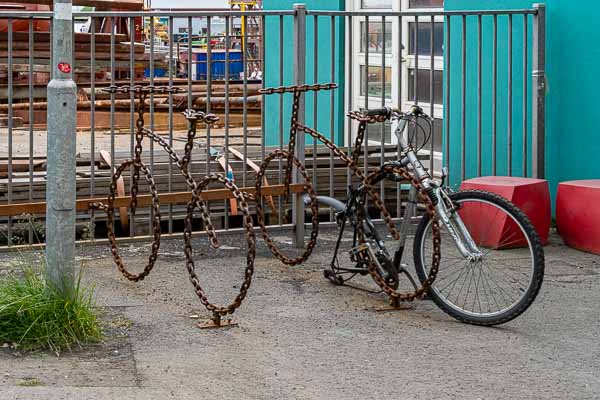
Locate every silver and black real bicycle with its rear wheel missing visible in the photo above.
<box><xmin>304</xmin><ymin>106</ymin><xmax>544</xmax><ymax>326</ymax></box>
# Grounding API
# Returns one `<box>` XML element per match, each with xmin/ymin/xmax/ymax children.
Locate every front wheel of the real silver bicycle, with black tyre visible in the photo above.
<box><xmin>413</xmin><ymin>191</ymin><xmax>544</xmax><ymax>326</ymax></box>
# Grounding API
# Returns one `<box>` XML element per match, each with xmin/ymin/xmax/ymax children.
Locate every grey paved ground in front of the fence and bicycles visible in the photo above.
<box><xmin>0</xmin><ymin>230</ymin><xmax>600</xmax><ymax>399</ymax></box>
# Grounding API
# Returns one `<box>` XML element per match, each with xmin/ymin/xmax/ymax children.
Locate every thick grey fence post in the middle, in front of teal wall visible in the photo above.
<box><xmin>292</xmin><ymin>4</ymin><xmax>306</xmax><ymax>248</ymax></box>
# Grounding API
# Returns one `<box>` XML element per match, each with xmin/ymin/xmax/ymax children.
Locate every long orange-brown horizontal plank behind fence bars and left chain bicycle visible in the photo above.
<box><xmin>0</xmin><ymin>184</ymin><xmax>304</xmax><ymax>217</ymax></box>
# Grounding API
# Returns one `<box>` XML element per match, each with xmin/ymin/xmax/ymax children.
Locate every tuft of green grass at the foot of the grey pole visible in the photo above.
<box><xmin>0</xmin><ymin>260</ymin><xmax>102</xmax><ymax>354</ymax></box>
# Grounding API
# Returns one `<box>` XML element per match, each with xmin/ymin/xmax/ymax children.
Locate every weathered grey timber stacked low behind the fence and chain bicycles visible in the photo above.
<box><xmin>0</xmin><ymin>146</ymin><xmax>426</xmax><ymax>231</ymax></box>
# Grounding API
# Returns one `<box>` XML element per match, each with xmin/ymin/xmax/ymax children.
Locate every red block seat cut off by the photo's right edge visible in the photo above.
<box><xmin>556</xmin><ymin>179</ymin><xmax>600</xmax><ymax>254</ymax></box>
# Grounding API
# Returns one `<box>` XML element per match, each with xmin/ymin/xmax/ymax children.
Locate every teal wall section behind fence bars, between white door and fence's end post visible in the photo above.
<box><xmin>445</xmin><ymin>0</ymin><xmax>533</xmax><ymax>191</ymax></box>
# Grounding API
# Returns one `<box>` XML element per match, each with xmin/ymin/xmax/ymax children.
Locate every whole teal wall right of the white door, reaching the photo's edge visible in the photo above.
<box><xmin>445</xmin><ymin>0</ymin><xmax>600</xmax><ymax>206</ymax></box>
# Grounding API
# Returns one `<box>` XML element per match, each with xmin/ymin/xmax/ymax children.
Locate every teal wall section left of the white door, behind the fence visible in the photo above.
<box><xmin>263</xmin><ymin>0</ymin><xmax>345</xmax><ymax>146</ymax></box>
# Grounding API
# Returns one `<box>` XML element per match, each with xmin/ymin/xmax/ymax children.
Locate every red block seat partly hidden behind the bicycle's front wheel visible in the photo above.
<box><xmin>460</xmin><ymin>176</ymin><xmax>551</xmax><ymax>249</ymax></box>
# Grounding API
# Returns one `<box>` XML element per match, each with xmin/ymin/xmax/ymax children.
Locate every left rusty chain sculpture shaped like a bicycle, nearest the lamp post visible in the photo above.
<box><xmin>90</xmin><ymin>85</ymin><xmax>256</xmax><ymax>322</ymax></box>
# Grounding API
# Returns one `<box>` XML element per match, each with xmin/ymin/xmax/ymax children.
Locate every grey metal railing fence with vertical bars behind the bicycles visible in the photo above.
<box><xmin>0</xmin><ymin>6</ymin><xmax>545</xmax><ymax>247</ymax></box>
